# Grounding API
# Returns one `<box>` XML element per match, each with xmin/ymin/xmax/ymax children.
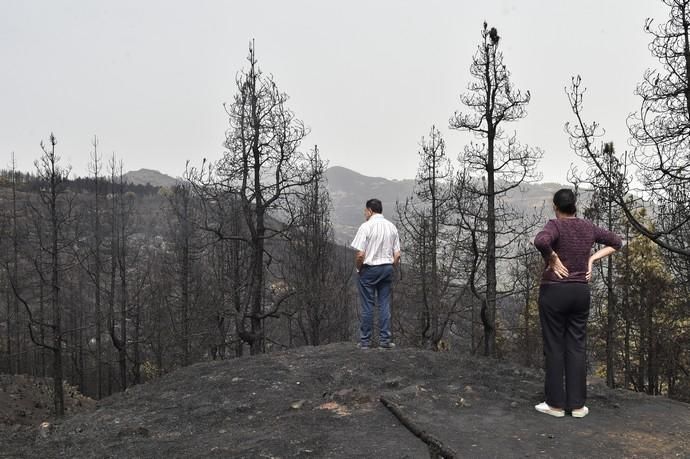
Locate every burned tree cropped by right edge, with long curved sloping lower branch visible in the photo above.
<box><xmin>566</xmin><ymin>0</ymin><xmax>690</xmax><ymax>257</ymax></box>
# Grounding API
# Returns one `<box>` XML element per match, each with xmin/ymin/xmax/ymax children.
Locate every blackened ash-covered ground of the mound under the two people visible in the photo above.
<box><xmin>0</xmin><ymin>343</ymin><xmax>690</xmax><ymax>458</ymax></box>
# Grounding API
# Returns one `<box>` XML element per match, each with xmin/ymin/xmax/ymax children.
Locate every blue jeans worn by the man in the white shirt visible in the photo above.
<box><xmin>358</xmin><ymin>265</ymin><xmax>393</xmax><ymax>345</ymax></box>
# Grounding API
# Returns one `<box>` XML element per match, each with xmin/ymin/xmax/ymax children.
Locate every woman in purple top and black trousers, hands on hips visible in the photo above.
<box><xmin>534</xmin><ymin>189</ymin><xmax>622</xmax><ymax>418</ymax></box>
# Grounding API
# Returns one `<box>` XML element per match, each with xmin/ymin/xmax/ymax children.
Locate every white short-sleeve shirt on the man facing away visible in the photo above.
<box><xmin>350</xmin><ymin>214</ymin><xmax>400</xmax><ymax>266</ymax></box>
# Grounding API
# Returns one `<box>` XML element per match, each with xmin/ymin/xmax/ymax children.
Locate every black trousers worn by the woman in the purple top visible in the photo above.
<box><xmin>539</xmin><ymin>283</ymin><xmax>590</xmax><ymax>410</ymax></box>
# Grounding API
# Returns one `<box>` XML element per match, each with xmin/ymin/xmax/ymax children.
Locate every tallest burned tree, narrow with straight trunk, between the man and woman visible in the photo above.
<box><xmin>450</xmin><ymin>23</ymin><xmax>542</xmax><ymax>355</ymax></box>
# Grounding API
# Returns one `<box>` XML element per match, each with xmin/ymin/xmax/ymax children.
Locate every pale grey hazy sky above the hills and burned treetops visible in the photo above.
<box><xmin>0</xmin><ymin>0</ymin><xmax>667</xmax><ymax>182</ymax></box>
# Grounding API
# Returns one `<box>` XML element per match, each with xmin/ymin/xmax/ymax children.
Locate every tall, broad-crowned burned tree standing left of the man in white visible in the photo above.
<box><xmin>191</xmin><ymin>44</ymin><xmax>309</xmax><ymax>354</ymax></box>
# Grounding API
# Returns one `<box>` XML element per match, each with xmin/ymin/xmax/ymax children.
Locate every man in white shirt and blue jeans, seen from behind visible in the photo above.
<box><xmin>350</xmin><ymin>199</ymin><xmax>400</xmax><ymax>349</ymax></box>
